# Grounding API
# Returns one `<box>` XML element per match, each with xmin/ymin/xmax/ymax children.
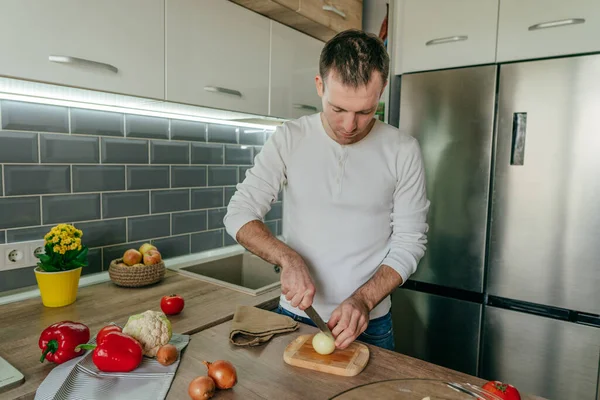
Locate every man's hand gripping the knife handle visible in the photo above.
<box><xmin>281</xmin><ymin>258</ymin><xmax>315</xmax><ymax>311</ymax></box>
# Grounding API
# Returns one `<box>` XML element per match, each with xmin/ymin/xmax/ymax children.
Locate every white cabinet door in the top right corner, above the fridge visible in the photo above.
<box><xmin>497</xmin><ymin>0</ymin><xmax>600</xmax><ymax>62</ymax></box>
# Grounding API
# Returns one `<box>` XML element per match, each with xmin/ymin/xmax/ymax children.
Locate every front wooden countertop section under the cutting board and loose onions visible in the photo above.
<box><xmin>167</xmin><ymin>321</ymin><xmax>539</xmax><ymax>400</ymax></box>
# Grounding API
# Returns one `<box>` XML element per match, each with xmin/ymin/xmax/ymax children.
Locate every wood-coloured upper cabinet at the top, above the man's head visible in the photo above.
<box><xmin>231</xmin><ymin>0</ymin><xmax>363</xmax><ymax>41</ymax></box>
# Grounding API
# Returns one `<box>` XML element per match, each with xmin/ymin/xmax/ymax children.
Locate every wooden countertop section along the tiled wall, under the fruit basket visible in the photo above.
<box><xmin>0</xmin><ymin>270</ymin><xmax>280</xmax><ymax>399</ymax></box>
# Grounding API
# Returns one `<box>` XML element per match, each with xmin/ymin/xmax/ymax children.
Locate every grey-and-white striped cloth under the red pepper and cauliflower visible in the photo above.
<box><xmin>35</xmin><ymin>333</ymin><xmax>190</xmax><ymax>400</ymax></box>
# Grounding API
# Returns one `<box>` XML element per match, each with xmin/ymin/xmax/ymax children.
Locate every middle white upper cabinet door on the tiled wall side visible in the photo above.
<box><xmin>166</xmin><ymin>0</ymin><xmax>270</xmax><ymax>115</ymax></box>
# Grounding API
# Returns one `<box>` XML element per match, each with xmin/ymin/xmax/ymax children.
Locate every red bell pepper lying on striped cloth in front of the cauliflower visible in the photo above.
<box><xmin>79</xmin><ymin>332</ymin><xmax>144</xmax><ymax>372</ymax></box>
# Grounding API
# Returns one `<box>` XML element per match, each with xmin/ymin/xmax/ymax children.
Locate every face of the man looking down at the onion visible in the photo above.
<box><xmin>316</xmin><ymin>70</ymin><xmax>385</xmax><ymax>144</ymax></box>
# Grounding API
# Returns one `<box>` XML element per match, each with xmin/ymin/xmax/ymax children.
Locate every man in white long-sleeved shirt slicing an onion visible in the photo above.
<box><xmin>224</xmin><ymin>30</ymin><xmax>429</xmax><ymax>349</ymax></box>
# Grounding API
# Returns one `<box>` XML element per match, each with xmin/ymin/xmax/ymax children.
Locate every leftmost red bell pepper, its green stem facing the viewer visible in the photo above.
<box><xmin>38</xmin><ymin>321</ymin><xmax>90</xmax><ymax>364</ymax></box>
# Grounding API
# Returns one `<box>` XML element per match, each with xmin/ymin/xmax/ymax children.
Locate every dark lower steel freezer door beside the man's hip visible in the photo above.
<box><xmin>392</xmin><ymin>288</ymin><xmax>482</xmax><ymax>375</ymax></box>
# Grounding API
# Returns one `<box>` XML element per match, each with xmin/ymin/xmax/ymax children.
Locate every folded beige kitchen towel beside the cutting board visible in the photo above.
<box><xmin>229</xmin><ymin>306</ymin><xmax>299</xmax><ymax>346</ymax></box>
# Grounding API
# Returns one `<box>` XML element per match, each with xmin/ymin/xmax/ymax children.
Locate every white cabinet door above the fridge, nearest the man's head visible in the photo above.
<box><xmin>400</xmin><ymin>0</ymin><xmax>498</xmax><ymax>73</ymax></box>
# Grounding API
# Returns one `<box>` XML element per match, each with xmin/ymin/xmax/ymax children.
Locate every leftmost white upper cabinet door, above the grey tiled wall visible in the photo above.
<box><xmin>0</xmin><ymin>0</ymin><xmax>165</xmax><ymax>99</ymax></box>
